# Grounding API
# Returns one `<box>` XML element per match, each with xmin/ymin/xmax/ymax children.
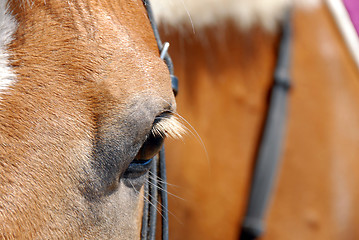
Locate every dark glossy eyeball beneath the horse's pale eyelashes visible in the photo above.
<box><xmin>135</xmin><ymin>133</ymin><xmax>164</xmax><ymax>160</ymax></box>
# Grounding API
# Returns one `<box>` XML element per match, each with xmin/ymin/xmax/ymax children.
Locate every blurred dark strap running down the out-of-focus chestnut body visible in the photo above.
<box><xmin>239</xmin><ymin>11</ymin><xmax>292</xmax><ymax>240</ymax></box>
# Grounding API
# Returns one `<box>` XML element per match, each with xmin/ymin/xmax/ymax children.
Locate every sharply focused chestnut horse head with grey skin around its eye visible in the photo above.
<box><xmin>0</xmin><ymin>0</ymin><xmax>183</xmax><ymax>239</ymax></box>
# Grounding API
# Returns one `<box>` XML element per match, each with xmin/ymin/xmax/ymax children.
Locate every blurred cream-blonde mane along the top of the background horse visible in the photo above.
<box><xmin>151</xmin><ymin>0</ymin><xmax>320</xmax><ymax>31</ymax></box>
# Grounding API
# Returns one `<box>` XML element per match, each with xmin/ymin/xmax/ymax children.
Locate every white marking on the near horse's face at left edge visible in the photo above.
<box><xmin>0</xmin><ymin>0</ymin><xmax>17</xmax><ymax>93</ymax></box>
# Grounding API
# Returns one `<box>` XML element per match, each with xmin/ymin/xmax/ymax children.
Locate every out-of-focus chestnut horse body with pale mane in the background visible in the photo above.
<box><xmin>154</xmin><ymin>0</ymin><xmax>359</xmax><ymax>240</ymax></box>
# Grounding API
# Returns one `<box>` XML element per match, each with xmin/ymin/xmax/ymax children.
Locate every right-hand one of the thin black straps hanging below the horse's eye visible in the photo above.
<box><xmin>159</xmin><ymin>146</ymin><xmax>169</xmax><ymax>240</ymax></box>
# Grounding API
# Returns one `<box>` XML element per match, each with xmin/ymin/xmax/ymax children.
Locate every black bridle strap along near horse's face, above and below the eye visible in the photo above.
<box><xmin>141</xmin><ymin>0</ymin><xmax>178</xmax><ymax>240</ymax></box>
